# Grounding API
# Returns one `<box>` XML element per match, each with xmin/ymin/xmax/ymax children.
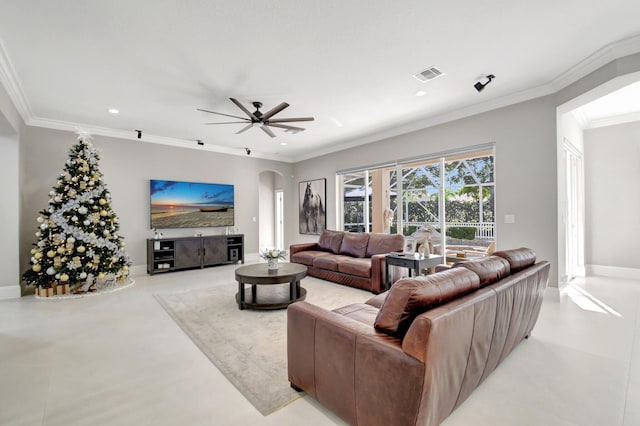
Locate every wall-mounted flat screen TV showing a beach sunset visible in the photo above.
<box><xmin>149</xmin><ymin>179</ymin><xmax>234</xmax><ymax>228</ymax></box>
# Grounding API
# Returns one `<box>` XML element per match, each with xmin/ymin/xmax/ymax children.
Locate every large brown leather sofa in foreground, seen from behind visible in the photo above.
<box><xmin>287</xmin><ymin>248</ymin><xmax>550</xmax><ymax>426</ymax></box>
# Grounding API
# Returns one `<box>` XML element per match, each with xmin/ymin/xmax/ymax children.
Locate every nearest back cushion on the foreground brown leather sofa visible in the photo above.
<box><xmin>374</xmin><ymin>268</ymin><xmax>480</xmax><ymax>336</ymax></box>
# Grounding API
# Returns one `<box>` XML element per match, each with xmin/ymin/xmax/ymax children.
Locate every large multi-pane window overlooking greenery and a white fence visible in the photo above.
<box><xmin>340</xmin><ymin>147</ymin><xmax>495</xmax><ymax>253</ymax></box>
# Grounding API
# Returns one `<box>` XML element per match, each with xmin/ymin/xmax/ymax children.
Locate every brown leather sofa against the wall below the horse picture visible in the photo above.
<box><xmin>289</xmin><ymin>230</ymin><xmax>404</xmax><ymax>294</ymax></box>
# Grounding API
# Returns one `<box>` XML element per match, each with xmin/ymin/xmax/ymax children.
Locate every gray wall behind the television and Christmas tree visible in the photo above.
<box><xmin>20</xmin><ymin>127</ymin><xmax>296</xmax><ymax>280</ymax></box>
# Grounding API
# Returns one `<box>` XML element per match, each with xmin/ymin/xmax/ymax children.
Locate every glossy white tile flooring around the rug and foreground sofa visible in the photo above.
<box><xmin>0</xmin><ymin>266</ymin><xmax>640</xmax><ymax>426</ymax></box>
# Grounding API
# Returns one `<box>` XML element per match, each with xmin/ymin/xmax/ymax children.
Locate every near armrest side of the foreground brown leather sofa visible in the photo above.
<box><xmin>287</xmin><ymin>302</ymin><xmax>425</xmax><ymax>425</ymax></box>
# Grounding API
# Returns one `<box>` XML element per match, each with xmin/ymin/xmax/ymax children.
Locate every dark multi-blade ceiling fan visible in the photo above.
<box><xmin>198</xmin><ymin>98</ymin><xmax>314</xmax><ymax>138</ymax></box>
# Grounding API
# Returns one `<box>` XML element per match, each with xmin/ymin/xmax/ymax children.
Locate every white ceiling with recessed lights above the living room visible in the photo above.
<box><xmin>0</xmin><ymin>0</ymin><xmax>640</xmax><ymax>161</ymax></box>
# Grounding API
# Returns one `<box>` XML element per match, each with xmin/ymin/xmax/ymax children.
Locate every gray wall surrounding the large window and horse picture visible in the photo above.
<box><xmin>294</xmin><ymin>96</ymin><xmax>558</xmax><ymax>282</ymax></box>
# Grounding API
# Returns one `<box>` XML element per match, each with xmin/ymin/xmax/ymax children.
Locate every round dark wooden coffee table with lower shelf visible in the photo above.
<box><xmin>236</xmin><ymin>263</ymin><xmax>307</xmax><ymax>309</ymax></box>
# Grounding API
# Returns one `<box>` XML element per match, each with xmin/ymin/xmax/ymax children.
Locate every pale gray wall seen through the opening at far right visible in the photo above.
<box><xmin>584</xmin><ymin>122</ymin><xmax>640</xmax><ymax>269</ymax></box>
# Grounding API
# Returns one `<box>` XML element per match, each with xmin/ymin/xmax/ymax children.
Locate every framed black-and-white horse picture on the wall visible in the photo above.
<box><xmin>299</xmin><ymin>179</ymin><xmax>327</xmax><ymax>235</ymax></box>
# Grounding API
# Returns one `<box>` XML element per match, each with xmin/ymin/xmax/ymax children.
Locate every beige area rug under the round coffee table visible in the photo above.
<box><xmin>155</xmin><ymin>277</ymin><xmax>373</xmax><ymax>416</ymax></box>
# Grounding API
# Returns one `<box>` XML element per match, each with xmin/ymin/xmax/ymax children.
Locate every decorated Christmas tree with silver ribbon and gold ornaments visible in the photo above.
<box><xmin>22</xmin><ymin>133</ymin><xmax>131</xmax><ymax>293</ymax></box>
